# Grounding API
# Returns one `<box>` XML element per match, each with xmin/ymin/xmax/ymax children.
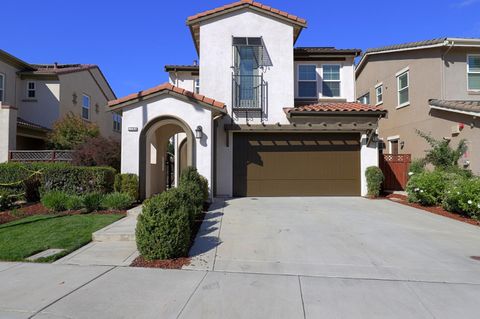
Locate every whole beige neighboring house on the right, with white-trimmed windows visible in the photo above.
<box><xmin>356</xmin><ymin>38</ymin><xmax>480</xmax><ymax>174</ymax></box>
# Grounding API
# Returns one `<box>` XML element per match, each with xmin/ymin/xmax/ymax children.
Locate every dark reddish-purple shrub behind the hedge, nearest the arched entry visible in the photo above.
<box><xmin>73</xmin><ymin>136</ymin><xmax>120</xmax><ymax>171</ymax></box>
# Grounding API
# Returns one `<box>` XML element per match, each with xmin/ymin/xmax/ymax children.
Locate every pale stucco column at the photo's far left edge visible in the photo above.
<box><xmin>0</xmin><ymin>104</ymin><xmax>17</xmax><ymax>163</ymax></box>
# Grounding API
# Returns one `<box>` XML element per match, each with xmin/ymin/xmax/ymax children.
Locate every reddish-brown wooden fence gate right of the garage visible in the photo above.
<box><xmin>380</xmin><ymin>154</ymin><xmax>412</xmax><ymax>191</ymax></box>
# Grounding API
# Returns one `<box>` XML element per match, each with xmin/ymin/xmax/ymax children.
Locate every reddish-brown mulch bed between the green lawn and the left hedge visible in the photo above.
<box><xmin>0</xmin><ymin>203</ymin><xmax>127</xmax><ymax>225</ymax></box>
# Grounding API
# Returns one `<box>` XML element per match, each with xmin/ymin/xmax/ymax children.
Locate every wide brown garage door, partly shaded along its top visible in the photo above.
<box><xmin>233</xmin><ymin>133</ymin><xmax>360</xmax><ymax>196</ymax></box>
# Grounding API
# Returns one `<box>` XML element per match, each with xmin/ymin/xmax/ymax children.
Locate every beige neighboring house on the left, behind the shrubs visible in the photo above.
<box><xmin>0</xmin><ymin>50</ymin><xmax>121</xmax><ymax>162</ymax></box>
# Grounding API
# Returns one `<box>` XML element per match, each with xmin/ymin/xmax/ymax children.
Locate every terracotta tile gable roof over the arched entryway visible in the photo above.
<box><xmin>108</xmin><ymin>83</ymin><xmax>226</xmax><ymax>111</ymax></box>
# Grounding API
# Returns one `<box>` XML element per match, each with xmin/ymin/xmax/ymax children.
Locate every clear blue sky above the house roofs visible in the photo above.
<box><xmin>1</xmin><ymin>0</ymin><xmax>480</xmax><ymax>97</ymax></box>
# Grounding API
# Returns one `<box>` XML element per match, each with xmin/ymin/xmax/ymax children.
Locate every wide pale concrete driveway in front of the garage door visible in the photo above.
<box><xmin>187</xmin><ymin>197</ymin><xmax>480</xmax><ymax>284</ymax></box>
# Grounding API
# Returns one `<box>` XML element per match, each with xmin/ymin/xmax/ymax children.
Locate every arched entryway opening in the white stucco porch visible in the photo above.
<box><xmin>139</xmin><ymin>116</ymin><xmax>195</xmax><ymax>198</ymax></box>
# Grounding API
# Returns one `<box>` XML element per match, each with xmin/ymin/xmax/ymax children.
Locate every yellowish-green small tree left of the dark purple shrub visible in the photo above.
<box><xmin>48</xmin><ymin>113</ymin><xmax>100</xmax><ymax>150</ymax></box>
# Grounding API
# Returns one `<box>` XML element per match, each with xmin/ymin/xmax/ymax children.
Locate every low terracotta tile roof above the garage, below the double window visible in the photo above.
<box><xmin>283</xmin><ymin>102</ymin><xmax>386</xmax><ymax>114</ymax></box>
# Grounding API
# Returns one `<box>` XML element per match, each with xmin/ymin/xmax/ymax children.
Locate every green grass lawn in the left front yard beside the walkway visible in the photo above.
<box><xmin>0</xmin><ymin>214</ymin><xmax>124</xmax><ymax>262</ymax></box>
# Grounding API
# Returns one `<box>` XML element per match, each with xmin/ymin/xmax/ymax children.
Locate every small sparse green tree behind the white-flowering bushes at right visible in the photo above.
<box><xmin>417</xmin><ymin>130</ymin><xmax>468</xmax><ymax>169</ymax></box>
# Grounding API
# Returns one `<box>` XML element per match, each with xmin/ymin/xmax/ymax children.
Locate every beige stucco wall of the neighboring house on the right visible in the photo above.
<box><xmin>356</xmin><ymin>48</ymin><xmax>480</xmax><ymax>174</ymax></box>
